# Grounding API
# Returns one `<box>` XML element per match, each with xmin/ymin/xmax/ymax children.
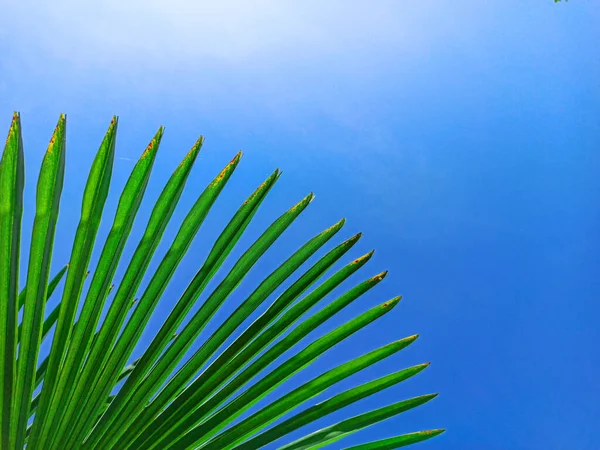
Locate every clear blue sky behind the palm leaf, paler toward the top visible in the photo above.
<box><xmin>0</xmin><ymin>0</ymin><xmax>600</xmax><ymax>450</ymax></box>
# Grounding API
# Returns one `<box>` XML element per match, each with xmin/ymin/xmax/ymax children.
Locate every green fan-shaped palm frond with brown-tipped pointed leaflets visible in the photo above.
<box><xmin>0</xmin><ymin>113</ymin><xmax>443</xmax><ymax>450</ymax></box>
